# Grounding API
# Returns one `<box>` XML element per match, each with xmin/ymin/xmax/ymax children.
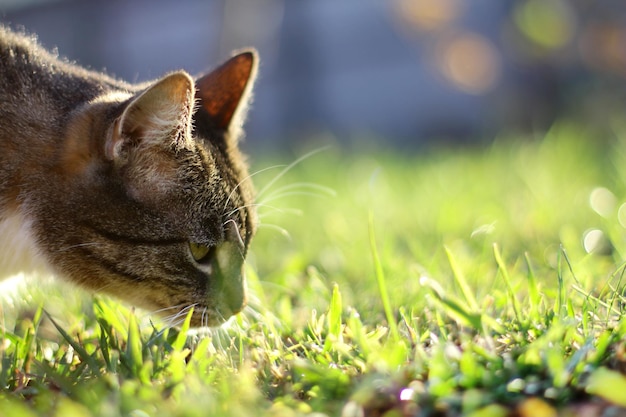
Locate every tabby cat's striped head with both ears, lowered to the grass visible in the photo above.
<box><xmin>36</xmin><ymin>51</ymin><xmax>257</xmax><ymax>326</ymax></box>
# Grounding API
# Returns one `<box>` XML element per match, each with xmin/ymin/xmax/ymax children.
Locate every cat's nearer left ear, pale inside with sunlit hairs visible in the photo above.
<box><xmin>105</xmin><ymin>71</ymin><xmax>194</xmax><ymax>160</ymax></box>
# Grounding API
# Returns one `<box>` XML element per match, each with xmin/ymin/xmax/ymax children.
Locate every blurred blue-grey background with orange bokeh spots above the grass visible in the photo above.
<box><xmin>0</xmin><ymin>0</ymin><xmax>626</xmax><ymax>150</ymax></box>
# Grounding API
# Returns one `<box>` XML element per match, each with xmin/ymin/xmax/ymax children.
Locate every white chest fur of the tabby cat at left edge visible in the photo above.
<box><xmin>0</xmin><ymin>214</ymin><xmax>48</xmax><ymax>280</ymax></box>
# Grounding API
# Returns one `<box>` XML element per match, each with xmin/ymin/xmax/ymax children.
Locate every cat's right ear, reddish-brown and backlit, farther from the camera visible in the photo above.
<box><xmin>196</xmin><ymin>50</ymin><xmax>259</xmax><ymax>131</ymax></box>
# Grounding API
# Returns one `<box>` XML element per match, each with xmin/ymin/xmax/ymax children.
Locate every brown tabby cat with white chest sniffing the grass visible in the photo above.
<box><xmin>0</xmin><ymin>25</ymin><xmax>258</xmax><ymax>327</ymax></box>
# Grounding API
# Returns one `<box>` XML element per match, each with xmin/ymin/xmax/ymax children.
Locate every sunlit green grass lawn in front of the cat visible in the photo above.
<box><xmin>0</xmin><ymin>123</ymin><xmax>626</xmax><ymax>417</ymax></box>
